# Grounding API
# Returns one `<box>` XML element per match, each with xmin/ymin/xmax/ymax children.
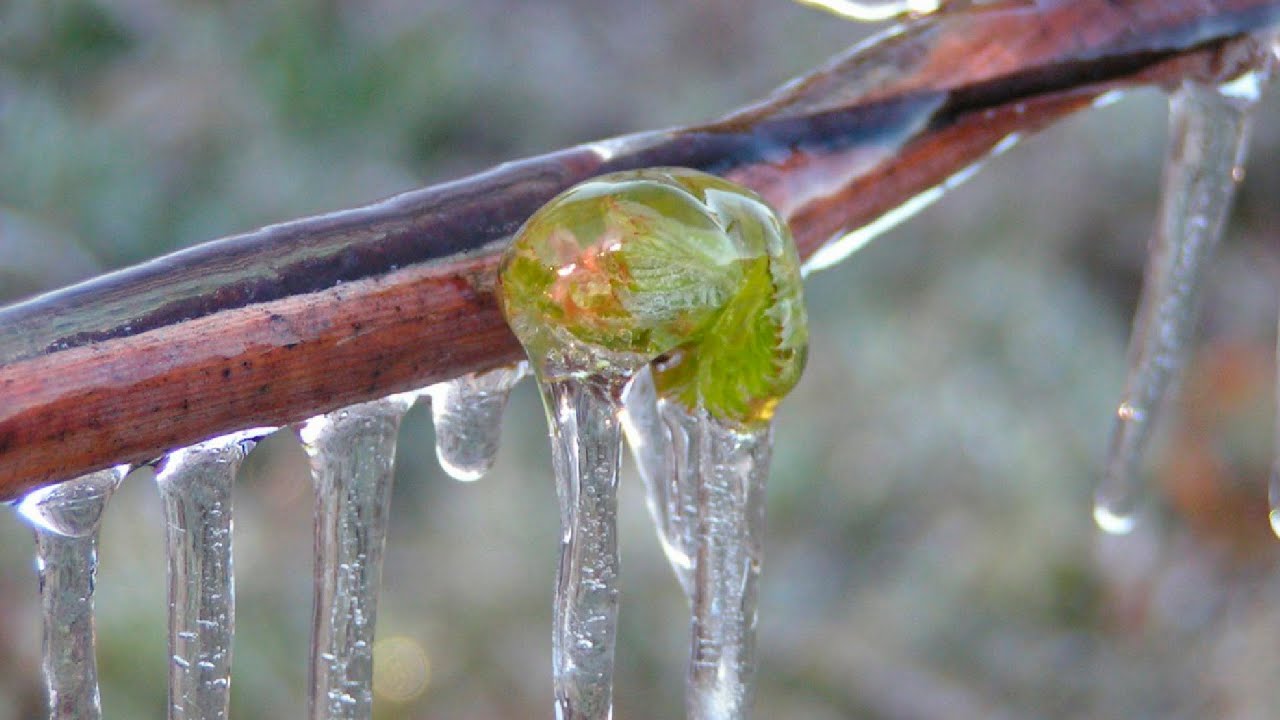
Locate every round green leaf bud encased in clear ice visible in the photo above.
<box><xmin>498</xmin><ymin>168</ymin><xmax>808</xmax><ymax>425</ymax></box>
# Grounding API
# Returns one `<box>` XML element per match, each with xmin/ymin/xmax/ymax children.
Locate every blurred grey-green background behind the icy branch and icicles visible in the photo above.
<box><xmin>0</xmin><ymin>0</ymin><xmax>1280</xmax><ymax>720</ymax></box>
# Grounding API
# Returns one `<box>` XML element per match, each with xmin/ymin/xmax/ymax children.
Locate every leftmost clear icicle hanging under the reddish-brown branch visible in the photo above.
<box><xmin>18</xmin><ymin>465</ymin><xmax>129</xmax><ymax>720</ymax></box>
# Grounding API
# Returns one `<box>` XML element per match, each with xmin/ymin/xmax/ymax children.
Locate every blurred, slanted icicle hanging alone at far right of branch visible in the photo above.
<box><xmin>1093</xmin><ymin>61</ymin><xmax>1266</xmax><ymax>534</ymax></box>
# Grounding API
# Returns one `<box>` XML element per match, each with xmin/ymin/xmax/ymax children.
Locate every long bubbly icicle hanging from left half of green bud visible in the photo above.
<box><xmin>539</xmin><ymin>375</ymin><xmax>625</xmax><ymax>720</ymax></box>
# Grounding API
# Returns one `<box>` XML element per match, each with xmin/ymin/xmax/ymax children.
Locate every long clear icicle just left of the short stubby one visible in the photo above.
<box><xmin>298</xmin><ymin>393</ymin><xmax>416</xmax><ymax>720</ymax></box>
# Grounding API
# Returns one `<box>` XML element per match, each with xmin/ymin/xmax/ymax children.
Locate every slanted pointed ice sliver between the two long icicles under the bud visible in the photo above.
<box><xmin>622</xmin><ymin>368</ymin><xmax>698</xmax><ymax>598</ymax></box>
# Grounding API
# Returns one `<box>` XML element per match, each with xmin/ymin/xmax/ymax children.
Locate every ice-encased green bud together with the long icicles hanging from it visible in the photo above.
<box><xmin>499</xmin><ymin>168</ymin><xmax>808</xmax><ymax>720</ymax></box>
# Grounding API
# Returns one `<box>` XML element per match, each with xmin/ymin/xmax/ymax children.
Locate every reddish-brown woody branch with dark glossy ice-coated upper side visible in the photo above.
<box><xmin>0</xmin><ymin>0</ymin><xmax>1280</xmax><ymax>498</ymax></box>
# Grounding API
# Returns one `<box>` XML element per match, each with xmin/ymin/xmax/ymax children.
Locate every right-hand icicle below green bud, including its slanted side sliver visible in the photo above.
<box><xmin>623</xmin><ymin>386</ymin><xmax>772</xmax><ymax>720</ymax></box>
